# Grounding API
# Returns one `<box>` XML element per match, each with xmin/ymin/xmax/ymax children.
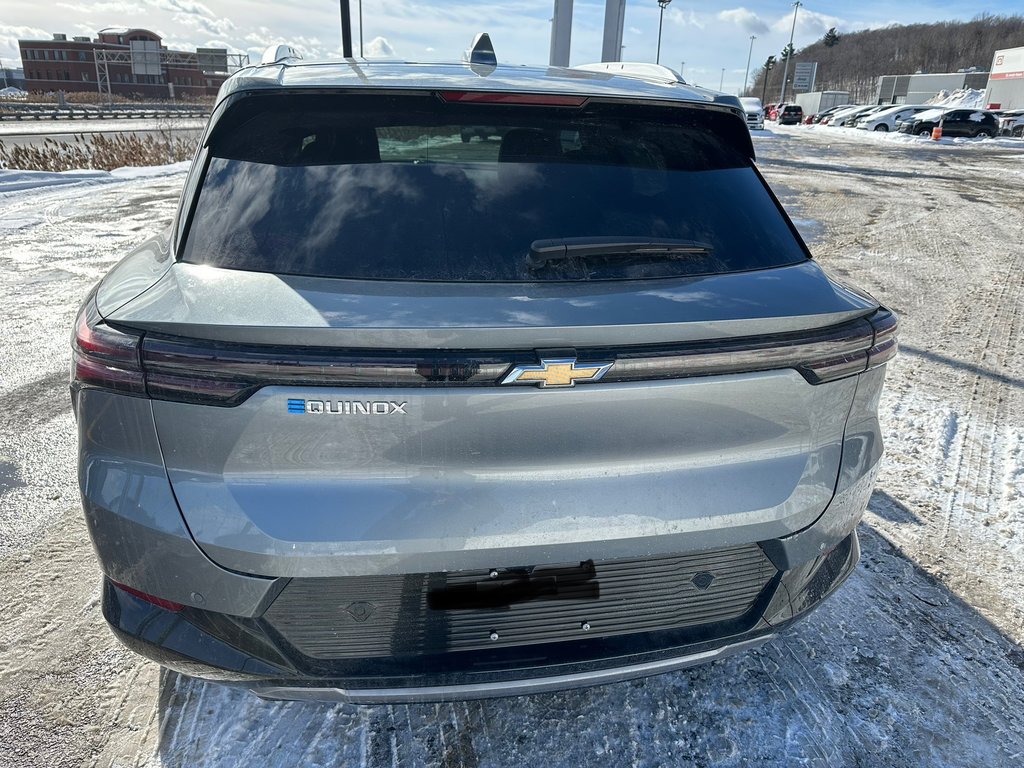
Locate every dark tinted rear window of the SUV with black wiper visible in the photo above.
<box><xmin>182</xmin><ymin>93</ymin><xmax>807</xmax><ymax>282</ymax></box>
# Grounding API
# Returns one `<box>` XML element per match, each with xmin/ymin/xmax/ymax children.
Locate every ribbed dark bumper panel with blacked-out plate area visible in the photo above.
<box><xmin>264</xmin><ymin>545</ymin><xmax>777</xmax><ymax>659</ymax></box>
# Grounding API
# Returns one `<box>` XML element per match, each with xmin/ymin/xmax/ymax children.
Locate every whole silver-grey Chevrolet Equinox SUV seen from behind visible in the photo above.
<box><xmin>72</xmin><ymin>40</ymin><xmax>896</xmax><ymax>701</ymax></box>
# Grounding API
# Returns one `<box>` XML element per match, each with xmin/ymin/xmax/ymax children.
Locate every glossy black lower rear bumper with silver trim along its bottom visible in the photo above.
<box><xmin>103</xmin><ymin>531</ymin><xmax>860</xmax><ymax>703</ymax></box>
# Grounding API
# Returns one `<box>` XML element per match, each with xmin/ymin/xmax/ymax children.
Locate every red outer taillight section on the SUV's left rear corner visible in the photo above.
<box><xmin>71</xmin><ymin>295</ymin><xmax>145</xmax><ymax>396</ymax></box>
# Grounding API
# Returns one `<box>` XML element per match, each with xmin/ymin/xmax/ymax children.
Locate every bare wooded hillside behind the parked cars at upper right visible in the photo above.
<box><xmin>748</xmin><ymin>14</ymin><xmax>1024</xmax><ymax>103</ymax></box>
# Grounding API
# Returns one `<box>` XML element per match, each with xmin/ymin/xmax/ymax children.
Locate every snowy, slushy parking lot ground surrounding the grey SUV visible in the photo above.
<box><xmin>0</xmin><ymin>126</ymin><xmax>1024</xmax><ymax>768</ymax></box>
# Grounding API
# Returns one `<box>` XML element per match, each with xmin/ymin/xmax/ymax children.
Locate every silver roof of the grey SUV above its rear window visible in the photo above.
<box><xmin>219</xmin><ymin>58</ymin><xmax>741</xmax><ymax>112</ymax></box>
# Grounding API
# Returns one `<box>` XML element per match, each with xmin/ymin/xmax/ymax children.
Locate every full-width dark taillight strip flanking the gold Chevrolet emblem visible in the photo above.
<box><xmin>72</xmin><ymin>286</ymin><xmax>898</xmax><ymax>408</ymax></box>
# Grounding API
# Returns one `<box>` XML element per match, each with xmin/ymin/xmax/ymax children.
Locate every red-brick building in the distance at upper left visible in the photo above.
<box><xmin>17</xmin><ymin>28</ymin><xmax>248</xmax><ymax>98</ymax></box>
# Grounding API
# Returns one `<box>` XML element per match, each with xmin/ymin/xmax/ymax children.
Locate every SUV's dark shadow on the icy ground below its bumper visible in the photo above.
<box><xmin>151</xmin><ymin>524</ymin><xmax>1024</xmax><ymax>767</ymax></box>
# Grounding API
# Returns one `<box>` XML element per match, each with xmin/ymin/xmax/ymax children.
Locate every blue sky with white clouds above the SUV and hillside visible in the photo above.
<box><xmin>0</xmin><ymin>0</ymin><xmax>1011</xmax><ymax>93</ymax></box>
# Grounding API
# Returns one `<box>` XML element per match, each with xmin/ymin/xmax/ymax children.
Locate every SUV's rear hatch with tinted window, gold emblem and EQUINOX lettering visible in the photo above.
<box><xmin>108</xmin><ymin>93</ymin><xmax>878</xmax><ymax>575</ymax></box>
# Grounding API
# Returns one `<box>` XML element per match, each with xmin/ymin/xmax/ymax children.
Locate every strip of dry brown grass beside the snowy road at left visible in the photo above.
<box><xmin>0</xmin><ymin>133</ymin><xmax>198</xmax><ymax>171</ymax></box>
